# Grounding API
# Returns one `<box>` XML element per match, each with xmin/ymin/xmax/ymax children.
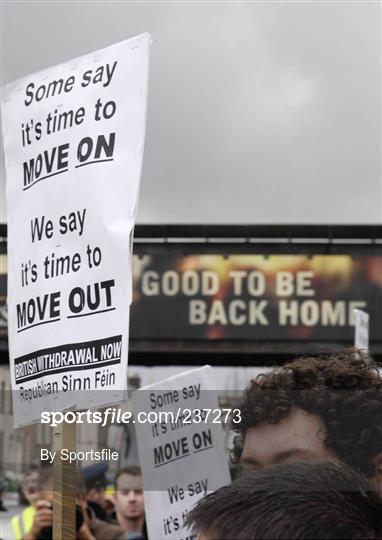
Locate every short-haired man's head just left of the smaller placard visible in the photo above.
<box><xmin>115</xmin><ymin>466</ymin><xmax>145</xmax><ymax>520</ymax></box>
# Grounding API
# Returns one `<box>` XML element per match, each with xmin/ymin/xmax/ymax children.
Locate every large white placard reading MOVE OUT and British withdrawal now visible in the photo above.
<box><xmin>2</xmin><ymin>34</ymin><xmax>151</xmax><ymax>425</ymax></box>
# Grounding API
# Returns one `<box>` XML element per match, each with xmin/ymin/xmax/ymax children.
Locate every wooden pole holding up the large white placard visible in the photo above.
<box><xmin>53</xmin><ymin>422</ymin><xmax>77</xmax><ymax>540</ymax></box>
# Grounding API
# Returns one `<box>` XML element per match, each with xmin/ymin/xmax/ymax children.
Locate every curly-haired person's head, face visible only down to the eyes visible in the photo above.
<box><xmin>232</xmin><ymin>351</ymin><xmax>382</xmax><ymax>492</ymax></box>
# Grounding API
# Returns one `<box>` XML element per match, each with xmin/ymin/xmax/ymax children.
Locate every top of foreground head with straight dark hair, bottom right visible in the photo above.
<box><xmin>188</xmin><ymin>461</ymin><xmax>382</xmax><ymax>540</ymax></box>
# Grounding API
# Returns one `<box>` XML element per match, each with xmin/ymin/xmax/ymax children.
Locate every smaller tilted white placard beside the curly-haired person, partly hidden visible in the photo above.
<box><xmin>133</xmin><ymin>366</ymin><xmax>231</xmax><ymax>540</ymax></box>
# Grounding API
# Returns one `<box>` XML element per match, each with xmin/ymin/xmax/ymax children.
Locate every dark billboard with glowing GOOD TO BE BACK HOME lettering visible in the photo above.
<box><xmin>131</xmin><ymin>254</ymin><xmax>382</xmax><ymax>343</ymax></box>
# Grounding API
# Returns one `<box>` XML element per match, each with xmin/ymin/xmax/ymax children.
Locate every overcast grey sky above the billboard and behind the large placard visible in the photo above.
<box><xmin>0</xmin><ymin>0</ymin><xmax>381</xmax><ymax>223</ymax></box>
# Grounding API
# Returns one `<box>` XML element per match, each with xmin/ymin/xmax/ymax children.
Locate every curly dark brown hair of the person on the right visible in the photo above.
<box><xmin>231</xmin><ymin>350</ymin><xmax>382</xmax><ymax>477</ymax></box>
